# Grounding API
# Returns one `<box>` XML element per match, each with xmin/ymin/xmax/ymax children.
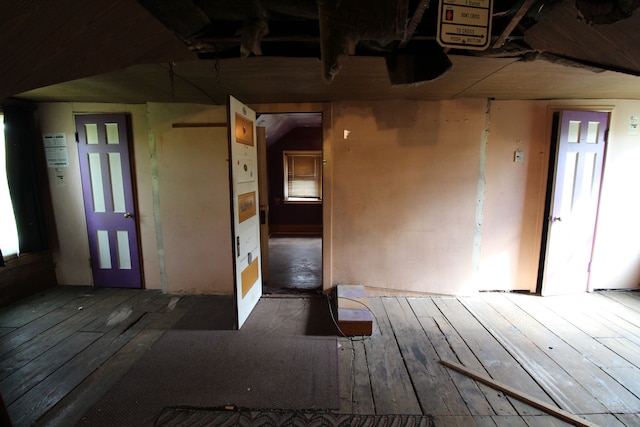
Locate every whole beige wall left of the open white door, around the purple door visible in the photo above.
<box><xmin>38</xmin><ymin>103</ymin><xmax>233</xmax><ymax>294</ymax></box>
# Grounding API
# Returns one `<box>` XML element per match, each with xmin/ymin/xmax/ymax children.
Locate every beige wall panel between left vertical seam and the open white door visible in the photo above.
<box><xmin>148</xmin><ymin>103</ymin><xmax>233</xmax><ymax>294</ymax></box>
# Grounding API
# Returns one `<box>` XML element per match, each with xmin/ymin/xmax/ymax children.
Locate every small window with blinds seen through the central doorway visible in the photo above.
<box><xmin>284</xmin><ymin>151</ymin><xmax>322</xmax><ymax>203</ymax></box>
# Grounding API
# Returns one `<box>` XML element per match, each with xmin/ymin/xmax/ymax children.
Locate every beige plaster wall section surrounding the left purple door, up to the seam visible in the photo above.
<box><xmin>37</xmin><ymin>102</ymin><xmax>160</xmax><ymax>288</ymax></box>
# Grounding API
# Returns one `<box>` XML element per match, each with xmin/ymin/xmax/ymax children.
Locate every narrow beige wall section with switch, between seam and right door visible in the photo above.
<box><xmin>478</xmin><ymin>101</ymin><xmax>551</xmax><ymax>291</ymax></box>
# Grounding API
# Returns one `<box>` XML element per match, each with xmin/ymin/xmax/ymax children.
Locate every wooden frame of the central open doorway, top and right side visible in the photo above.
<box><xmin>247</xmin><ymin>102</ymin><xmax>333</xmax><ymax>293</ymax></box>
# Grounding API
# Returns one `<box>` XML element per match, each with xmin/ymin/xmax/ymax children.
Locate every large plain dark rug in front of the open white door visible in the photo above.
<box><xmin>79</xmin><ymin>330</ymin><xmax>339</xmax><ymax>426</ymax></box>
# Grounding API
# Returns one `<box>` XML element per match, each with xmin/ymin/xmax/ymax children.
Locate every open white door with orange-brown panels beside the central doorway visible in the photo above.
<box><xmin>228</xmin><ymin>96</ymin><xmax>262</xmax><ymax>328</ymax></box>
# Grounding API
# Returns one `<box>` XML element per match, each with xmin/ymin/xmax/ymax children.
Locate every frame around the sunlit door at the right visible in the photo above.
<box><xmin>530</xmin><ymin>105</ymin><xmax>615</xmax><ymax>294</ymax></box>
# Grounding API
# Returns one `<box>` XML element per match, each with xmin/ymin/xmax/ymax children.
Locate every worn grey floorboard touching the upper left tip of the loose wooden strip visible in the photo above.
<box><xmin>382</xmin><ymin>298</ymin><xmax>471</xmax><ymax>416</ymax></box>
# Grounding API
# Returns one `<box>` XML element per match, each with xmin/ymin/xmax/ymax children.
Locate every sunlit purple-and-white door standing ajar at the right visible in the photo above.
<box><xmin>542</xmin><ymin>111</ymin><xmax>609</xmax><ymax>295</ymax></box>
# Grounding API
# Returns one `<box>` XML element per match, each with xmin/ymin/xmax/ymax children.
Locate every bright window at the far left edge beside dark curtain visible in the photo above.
<box><xmin>0</xmin><ymin>113</ymin><xmax>18</xmax><ymax>258</ymax></box>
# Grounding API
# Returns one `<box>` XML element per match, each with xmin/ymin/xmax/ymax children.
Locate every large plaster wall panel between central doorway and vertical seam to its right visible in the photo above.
<box><xmin>332</xmin><ymin>100</ymin><xmax>486</xmax><ymax>294</ymax></box>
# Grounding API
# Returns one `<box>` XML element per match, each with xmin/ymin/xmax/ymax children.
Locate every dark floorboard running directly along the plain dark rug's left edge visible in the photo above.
<box><xmin>34</xmin><ymin>298</ymin><xmax>189</xmax><ymax>427</ymax></box>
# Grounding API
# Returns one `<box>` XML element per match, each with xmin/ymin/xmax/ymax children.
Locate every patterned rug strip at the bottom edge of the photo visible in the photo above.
<box><xmin>155</xmin><ymin>407</ymin><xmax>435</xmax><ymax>427</ymax></box>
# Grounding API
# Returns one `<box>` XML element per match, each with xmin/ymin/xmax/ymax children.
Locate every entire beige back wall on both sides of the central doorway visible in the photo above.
<box><xmin>38</xmin><ymin>100</ymin><xmax>640</xmax><ymax>294</ymax></box>
